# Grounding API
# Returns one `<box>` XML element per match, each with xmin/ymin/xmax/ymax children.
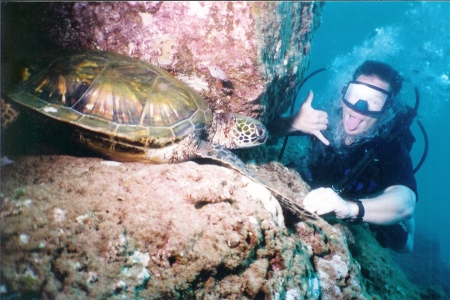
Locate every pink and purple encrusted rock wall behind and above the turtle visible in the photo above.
<box><xmin>34</xmin><ymin>1</ymin><xmax>323</xmax><ymax>121</ymax></box>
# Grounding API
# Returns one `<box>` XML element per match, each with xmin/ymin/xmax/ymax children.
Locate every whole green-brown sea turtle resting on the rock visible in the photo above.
<box><xmin>2</xmin><ymin>51</ymin><xmax>315</xmax><ymax>221</ymax></box>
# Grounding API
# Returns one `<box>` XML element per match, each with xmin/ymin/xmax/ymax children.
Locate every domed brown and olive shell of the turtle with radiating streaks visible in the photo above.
<box><xmin>8</xmin><ymin>51</ymin><xmax>212</xmax><ymax>161</ymax></box>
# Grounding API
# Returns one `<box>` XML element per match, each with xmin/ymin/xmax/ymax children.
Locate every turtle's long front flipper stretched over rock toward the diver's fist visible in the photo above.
<box><xmin>196</xmin><ymin>141</ymin><xmax>319</xmax><ymax>220</ymax></box>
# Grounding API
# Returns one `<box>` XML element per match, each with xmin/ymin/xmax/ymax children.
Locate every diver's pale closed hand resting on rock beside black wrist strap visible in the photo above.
<box><xmin>303</xmin><ymin>188</ymin><xmax>358</xmax><ymax>219</ymax></box>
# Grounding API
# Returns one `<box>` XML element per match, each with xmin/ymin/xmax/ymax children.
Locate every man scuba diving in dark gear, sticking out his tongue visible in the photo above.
<box><xmin>269</xmin><ymin>60</ymin><xmax>417</xmax><ymax>252</ymax></box>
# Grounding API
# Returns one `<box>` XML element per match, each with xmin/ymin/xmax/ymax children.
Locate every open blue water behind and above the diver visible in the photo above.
<box><xmin>297</xmin><ymin>2</ymin><xmax>450</xmax><ymax>284</ymax></box>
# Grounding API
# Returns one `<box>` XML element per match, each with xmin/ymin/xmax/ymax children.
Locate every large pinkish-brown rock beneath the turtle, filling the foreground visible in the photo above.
<box><xmin>0</xmin><ymin>155</ymin><xmax>428</xmax><ymax>299</ymax></box>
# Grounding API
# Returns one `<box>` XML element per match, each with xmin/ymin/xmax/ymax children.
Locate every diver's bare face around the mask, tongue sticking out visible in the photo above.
<box><xmin>342</xmin><ymin>75</ymin><xmax>391</xmax><ymax>136</ymax></box>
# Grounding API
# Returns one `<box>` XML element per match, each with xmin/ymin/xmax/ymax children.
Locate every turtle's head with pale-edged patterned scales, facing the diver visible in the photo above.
<box><xmin>208</xmin><ymin>113</ymin><xmax>268</xmax><ymax>149</ymax></box>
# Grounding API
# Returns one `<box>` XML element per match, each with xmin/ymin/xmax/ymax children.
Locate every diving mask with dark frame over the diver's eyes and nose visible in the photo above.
<box><xmin>342</xmin><ymin>81</ymin><xmax>392</xmax><ymax>117</ymax></box>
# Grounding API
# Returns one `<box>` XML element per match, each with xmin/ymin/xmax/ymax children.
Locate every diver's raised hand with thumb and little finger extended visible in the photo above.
<box><xmin>289</xmin><ymin>91</ymin><xmax>330</xmax><ymax>146</ymax></box>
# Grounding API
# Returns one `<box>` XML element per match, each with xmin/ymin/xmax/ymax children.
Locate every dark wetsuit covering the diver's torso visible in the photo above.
<box><xmin>288</xmin><ymin>132</ymin><xmax>417</xmax><ymax>249</ymax></box>
